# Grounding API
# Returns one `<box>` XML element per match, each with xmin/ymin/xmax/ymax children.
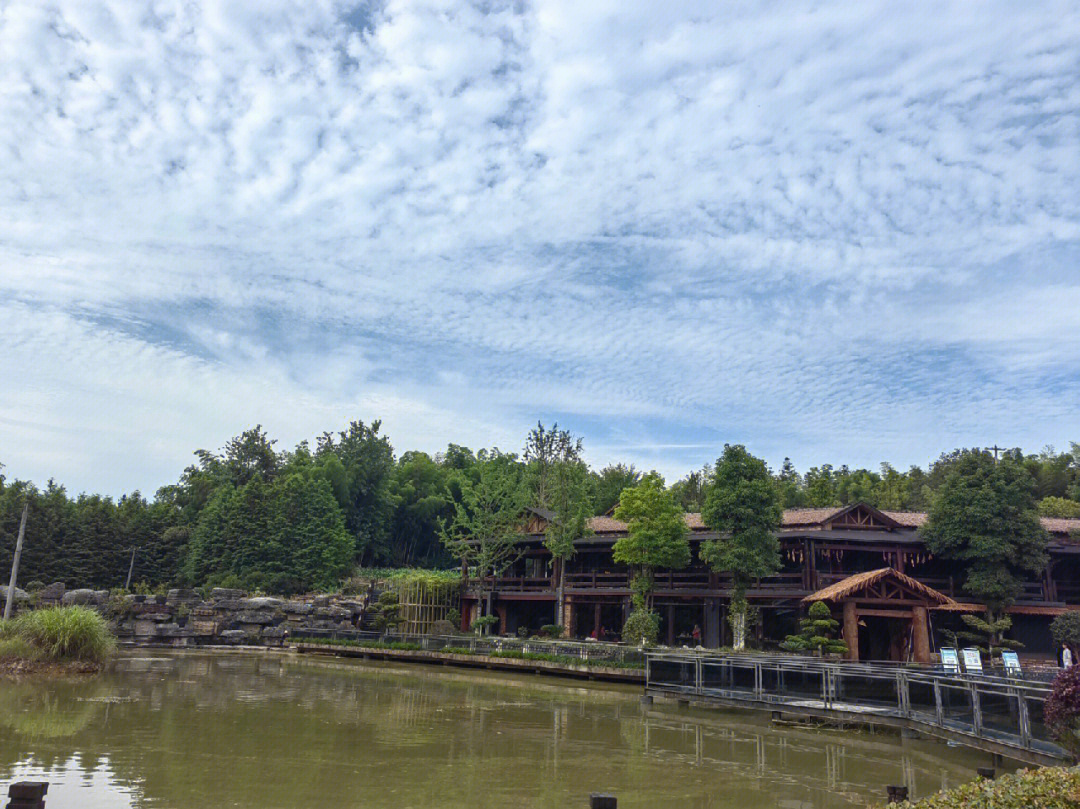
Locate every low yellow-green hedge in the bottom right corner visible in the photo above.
<box><xmin>893</xmin><ymin>767</ymin><xmax>1080</xmax><ymax>809</ymax></box>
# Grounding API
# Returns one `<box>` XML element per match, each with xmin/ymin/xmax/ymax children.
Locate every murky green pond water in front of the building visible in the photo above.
<box><xmin>0</xmin><ymin>652</ymin><xmax>1010</xmax><ymax>809</ymax></box>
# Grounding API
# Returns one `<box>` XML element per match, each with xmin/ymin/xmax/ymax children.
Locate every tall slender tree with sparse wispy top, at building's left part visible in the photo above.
<box><xmin>525</xmin><ymin>422</ymin><xmax>591</xmax><ymax>624</ymax></box>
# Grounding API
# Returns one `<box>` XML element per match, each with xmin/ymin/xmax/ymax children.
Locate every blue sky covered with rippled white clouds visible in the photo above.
<box><xmin>0</xmin><ymin>0</ymin><xmax>1080</xmax><ymax>495</ymax></box>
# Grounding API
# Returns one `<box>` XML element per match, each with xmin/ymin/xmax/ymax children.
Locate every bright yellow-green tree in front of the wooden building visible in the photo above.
<box><xmin>611</xmin><ymin>472</ymin><xmax>690</xmax><ymax>610</ymax></box>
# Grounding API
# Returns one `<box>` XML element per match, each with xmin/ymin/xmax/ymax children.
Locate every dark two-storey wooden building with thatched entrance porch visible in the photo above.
<box><xmin>461</xmin><ymin>503</ymin><xmax>1080</xmax><ymax>660</ymax></box>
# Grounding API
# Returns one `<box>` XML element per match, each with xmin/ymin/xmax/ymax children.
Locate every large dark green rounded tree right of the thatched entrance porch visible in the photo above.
<box><xmin>920</xmin><ymin>449</ymin><xmax>1047</xmax><ymax>647</ymax></box>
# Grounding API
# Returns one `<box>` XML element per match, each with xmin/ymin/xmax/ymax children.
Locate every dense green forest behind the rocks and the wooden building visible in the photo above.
<box><xmin>0</xmin><ymin>421</ymin><xmax>1080</xmax><ymax>593</ymax></box>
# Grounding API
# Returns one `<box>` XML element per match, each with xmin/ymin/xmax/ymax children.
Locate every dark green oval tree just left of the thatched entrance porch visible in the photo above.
<box><xmin>699</xmin><ymin>444</ymin><xmax>783</xmax><ymax>649</ymax></box>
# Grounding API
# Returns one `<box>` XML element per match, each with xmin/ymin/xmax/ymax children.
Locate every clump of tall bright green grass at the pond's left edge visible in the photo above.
<box><xmin>0</xmin><ymin>606</ymin><xmax>117</xmax><ymax>663</ymax></box>
